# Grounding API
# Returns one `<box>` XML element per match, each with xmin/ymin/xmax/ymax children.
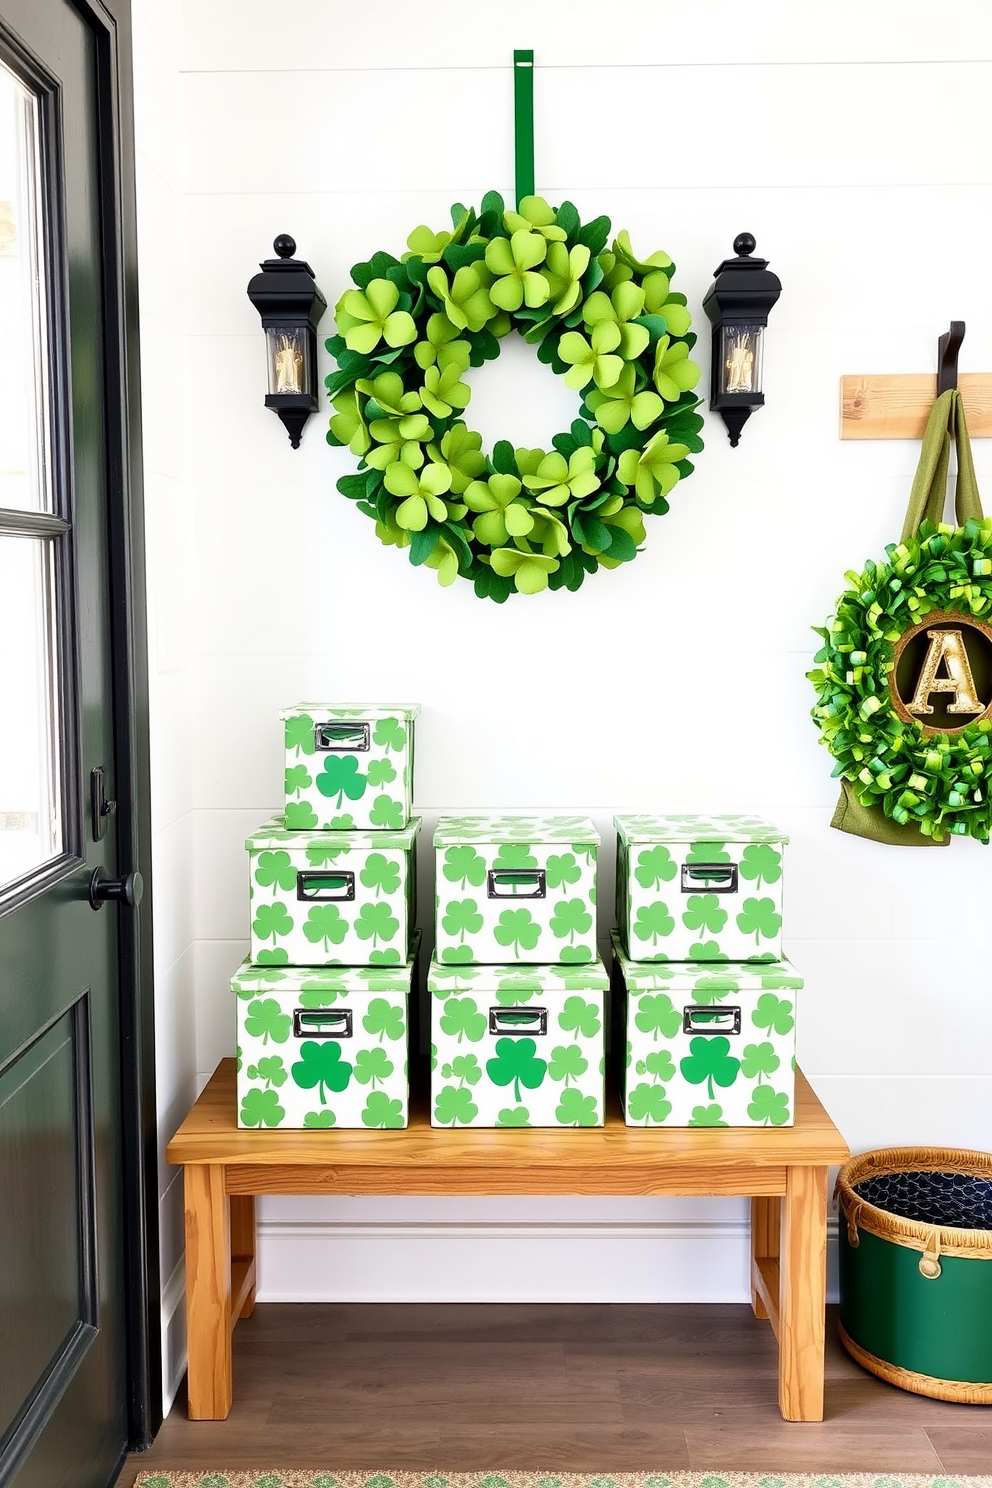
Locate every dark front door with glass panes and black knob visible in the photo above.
<box><xmin>0</xmin><ymin>0</ymin><xmax>153</xmax><ymax>1488</ymax></box>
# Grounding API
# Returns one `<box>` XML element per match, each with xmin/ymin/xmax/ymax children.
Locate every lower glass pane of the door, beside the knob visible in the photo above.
<box><xmin>0</xmin><ymin>533</ymin><xmax>62</xmax><ymax>894</ymax></box>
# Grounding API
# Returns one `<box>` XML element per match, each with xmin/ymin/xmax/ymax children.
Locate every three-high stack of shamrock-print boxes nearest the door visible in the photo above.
<box><xmin>231</xmin><ymin>704</ymin><xmax>421</xmax><ymax>1128</ymax></box>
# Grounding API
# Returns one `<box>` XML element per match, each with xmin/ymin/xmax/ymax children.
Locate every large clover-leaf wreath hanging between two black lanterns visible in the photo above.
<box><xmin>327</xmin><ymin>192</ymin><xmax>702</xmax><ymax>604</ymax></box>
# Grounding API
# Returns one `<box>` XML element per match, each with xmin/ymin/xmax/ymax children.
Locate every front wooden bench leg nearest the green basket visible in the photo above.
<box><xmin>778</xmin><ymin>1167</ymin><xmax>827</xmax><ymax>1421</ymax></box>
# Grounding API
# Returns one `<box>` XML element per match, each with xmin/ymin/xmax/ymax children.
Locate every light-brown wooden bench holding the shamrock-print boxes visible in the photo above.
<box><xmin>167</xmin><ymin>1059</ymin><xmax>849</xmax><ymax>1421</ymax></box>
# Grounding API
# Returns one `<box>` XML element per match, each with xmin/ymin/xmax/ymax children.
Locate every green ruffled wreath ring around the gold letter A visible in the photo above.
<box><xmin>808</xmin><ymin>519</ymin><xmax>992</xmax><ymax>842</ymax></box>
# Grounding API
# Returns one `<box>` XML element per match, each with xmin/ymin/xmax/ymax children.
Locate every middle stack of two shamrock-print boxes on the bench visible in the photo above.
<box><xmin>427</xmin><ymin>815</ymin><xmax>608</xmax><ymax>1126</ymax></box>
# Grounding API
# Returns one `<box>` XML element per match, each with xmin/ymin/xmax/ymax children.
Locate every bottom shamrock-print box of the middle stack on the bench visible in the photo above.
<box><xmin>427</xmin><ymin>958</ymin><xmax>610</xmax><ymax>1126</ymax></box>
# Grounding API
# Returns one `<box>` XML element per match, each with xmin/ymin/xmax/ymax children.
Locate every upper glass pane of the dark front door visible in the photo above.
<box><xmin>0</xmin><ymin>62</ymin><xmax>52</xmax><ymax>512</ymax></box>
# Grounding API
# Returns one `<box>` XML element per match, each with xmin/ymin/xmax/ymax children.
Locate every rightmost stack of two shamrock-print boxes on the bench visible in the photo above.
<box><xmin>613</xmin><ymin>815</ymin><xmax>803</xmax><ymax>1126</ymax></box>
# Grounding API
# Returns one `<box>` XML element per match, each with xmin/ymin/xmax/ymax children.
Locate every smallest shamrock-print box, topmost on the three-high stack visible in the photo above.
<box><xmin>280</xmin><ymin>702</ymin><xmax>419</xmax><ymax>832</ymax></box>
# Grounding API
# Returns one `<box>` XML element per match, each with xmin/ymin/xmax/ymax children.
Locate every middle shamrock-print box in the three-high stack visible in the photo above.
<box><xmin>245</xmin><ymin>817</ymin><xmax>421</xmax><ymax>966</ymax></box>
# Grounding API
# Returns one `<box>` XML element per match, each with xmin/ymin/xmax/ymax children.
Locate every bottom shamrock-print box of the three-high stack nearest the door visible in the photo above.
<box><xmin>231</xmin><ymin>936</ymin><xmax>419</xmax><ymax>1129</ymax></box>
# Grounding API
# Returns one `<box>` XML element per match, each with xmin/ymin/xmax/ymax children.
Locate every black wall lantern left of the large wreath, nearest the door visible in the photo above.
<box><xmin>248</xmin><ymin>232</ymin><xmax>327</xmax><ymax>449</ymax></box>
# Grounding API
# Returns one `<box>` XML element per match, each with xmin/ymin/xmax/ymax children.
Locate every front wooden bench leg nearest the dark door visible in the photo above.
<box><xmin>184</xmin><ymin>1162</ymin><xmax>232</xmax><ymax>1421</ymax></box>
